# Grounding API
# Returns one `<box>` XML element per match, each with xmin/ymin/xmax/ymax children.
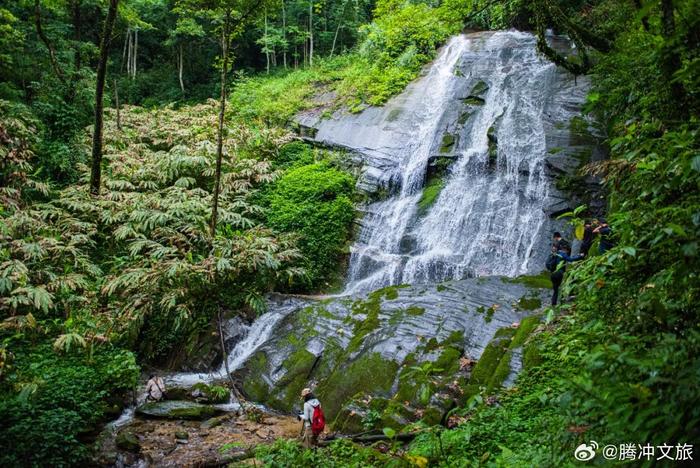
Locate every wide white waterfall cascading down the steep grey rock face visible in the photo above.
<box><xmin>346</xmin><ymin>31</ymin><xmax>556</xmax><ymax>293</ymax></box>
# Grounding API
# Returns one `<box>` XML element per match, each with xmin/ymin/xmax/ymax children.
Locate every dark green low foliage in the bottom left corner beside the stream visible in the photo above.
<box><xmin>0</xmin><ymin>342</ymin><xmax>138</xmax><ymax>466</ymax></box>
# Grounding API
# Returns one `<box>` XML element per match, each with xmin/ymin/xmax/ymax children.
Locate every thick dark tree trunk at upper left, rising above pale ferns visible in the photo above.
<box><xmin>90</xmin><ymin>0</ymin><xmax>119</xmax><ymax>196</ymax></box>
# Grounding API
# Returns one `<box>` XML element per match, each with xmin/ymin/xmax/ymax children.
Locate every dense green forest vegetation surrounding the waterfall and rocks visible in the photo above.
<box><xmin>0</xmin><ymin>0</ymin><xmax>700</xmax><ymax>467</ymax></box>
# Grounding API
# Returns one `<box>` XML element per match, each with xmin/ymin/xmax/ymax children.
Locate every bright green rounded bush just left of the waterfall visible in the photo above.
<box><xmin>267</xmin><ymin>163</ymin><xmax>355</xmax><ymax>289</ymax></box>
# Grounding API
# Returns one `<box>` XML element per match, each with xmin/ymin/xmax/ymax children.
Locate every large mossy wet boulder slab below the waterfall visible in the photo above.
<box><xmin>235</xmin><ymin>277</ymin><xmax>548</xmax><ymax>431</ymax></box>
